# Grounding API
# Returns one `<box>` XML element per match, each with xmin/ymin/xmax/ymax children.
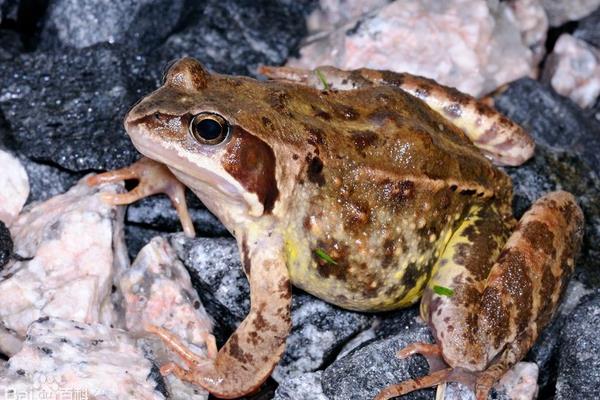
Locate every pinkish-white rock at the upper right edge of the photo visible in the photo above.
<box><xmin>543</xmin><ymin>33</ymin><xmax>600</xmax><ymax>108</ymax></box>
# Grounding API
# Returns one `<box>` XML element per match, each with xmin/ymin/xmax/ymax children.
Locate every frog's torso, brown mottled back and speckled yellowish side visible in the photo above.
<box><xmin>264</xmin><ymin>82</ymin><xmax>510</xmax><ymax>310</ymax></box>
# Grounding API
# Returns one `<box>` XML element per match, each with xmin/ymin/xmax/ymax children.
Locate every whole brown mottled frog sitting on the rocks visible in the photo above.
<box><xmin>89</xmin><ymin>58</ymin><xmax>584</xmax><ymax>400</ymax></box>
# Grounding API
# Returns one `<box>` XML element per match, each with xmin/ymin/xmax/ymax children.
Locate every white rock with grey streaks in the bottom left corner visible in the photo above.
<box><xmin>0</xmin><ymin>318</ymin><xmax>164</xmax><ymax>400</ymax></box>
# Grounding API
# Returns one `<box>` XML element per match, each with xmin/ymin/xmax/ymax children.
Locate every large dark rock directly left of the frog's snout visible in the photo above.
<box><xmin>0</xmin><ymin>45</ymin><xmax>154</xmax><ymax>171</ymax></box>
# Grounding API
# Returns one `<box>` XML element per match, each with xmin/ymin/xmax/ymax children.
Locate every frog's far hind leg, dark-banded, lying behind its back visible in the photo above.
<box><xmin>259</xmin><ymin>66</ymin><xmax>535</xmax><ymax>165</ymax></box>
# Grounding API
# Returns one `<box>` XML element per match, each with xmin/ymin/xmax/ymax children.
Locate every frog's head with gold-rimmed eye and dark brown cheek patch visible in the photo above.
<box><xmin>125</xmin><ymin>58</ymin><xmax>280</xmax><ymax>230</ymax></box>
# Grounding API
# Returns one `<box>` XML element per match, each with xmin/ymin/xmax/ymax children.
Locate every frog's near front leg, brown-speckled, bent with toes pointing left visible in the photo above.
<box><xmin>151</xmin><ymin>231</ymin><xmax>292</xmax><ymax>399</ymax></box>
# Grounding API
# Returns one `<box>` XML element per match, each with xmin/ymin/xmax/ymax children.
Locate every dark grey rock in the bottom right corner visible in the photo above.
<box><xmin>554</xmin><ymin>291</ymin><xmax>600</xmax><ymax>400</ymax></box>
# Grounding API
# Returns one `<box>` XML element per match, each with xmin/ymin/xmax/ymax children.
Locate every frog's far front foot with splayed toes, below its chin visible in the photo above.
<box><xmin>87</xmin><ymin>157</ymin><xmax>196</xmax><ymax>237</ymax></box>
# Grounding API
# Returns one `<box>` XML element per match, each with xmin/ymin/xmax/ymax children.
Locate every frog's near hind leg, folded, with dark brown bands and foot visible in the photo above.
<box><xmin>376</xmin><ymin>192</ymin><xmax>583</xmax><ymax>400</ymax></box>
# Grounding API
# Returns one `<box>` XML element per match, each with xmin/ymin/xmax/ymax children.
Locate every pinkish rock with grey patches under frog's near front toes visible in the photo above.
<box><xmin>117</xmin><ymin>237</ymin><xmax>212</xmax><ymax>400</ymax></box>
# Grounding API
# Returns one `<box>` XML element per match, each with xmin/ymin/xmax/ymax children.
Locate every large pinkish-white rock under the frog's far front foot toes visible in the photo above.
<box><xmin>0</xmin><ymin>177</ymin><xmax>128</xmax><ymax>355</ymax></box>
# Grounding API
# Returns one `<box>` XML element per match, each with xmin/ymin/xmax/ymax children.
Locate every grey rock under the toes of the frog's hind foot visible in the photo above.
<box><xmin>322</xmin><ymin>307</ymin><xmax>434</xmax><ymax>400</ymax></box>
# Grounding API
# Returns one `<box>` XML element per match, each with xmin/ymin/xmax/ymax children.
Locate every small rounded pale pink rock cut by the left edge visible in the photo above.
<box><xmin>0</xmin><ymin>150</ymin><xmax>29</xmax><ymax>225</ymax></box>
